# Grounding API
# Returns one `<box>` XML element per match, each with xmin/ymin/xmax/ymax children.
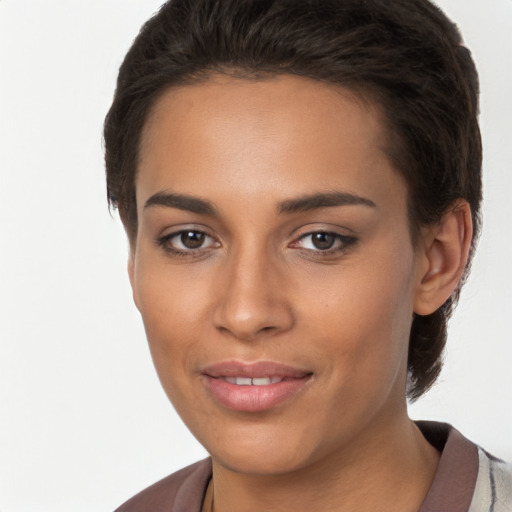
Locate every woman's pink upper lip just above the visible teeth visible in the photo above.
<box><xmin>201</xmin><ymin>361</ymin><xmax>312</xmax><ymax>379</ymax></box>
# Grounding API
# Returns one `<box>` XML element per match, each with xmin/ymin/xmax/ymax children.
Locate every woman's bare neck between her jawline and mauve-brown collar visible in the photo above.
<box><xmin>205</xmin><ymin>417</ymin><xmax>439</xmax><ymax>512</ymax></box>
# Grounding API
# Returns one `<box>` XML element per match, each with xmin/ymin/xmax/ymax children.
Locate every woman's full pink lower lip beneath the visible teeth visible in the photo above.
<box><xmin>204</xmin><ymin>375</ymin><xmax>311</xmax><ymax>412</ymax></box>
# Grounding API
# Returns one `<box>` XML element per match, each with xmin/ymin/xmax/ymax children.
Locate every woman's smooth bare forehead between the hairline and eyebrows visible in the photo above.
<box><xmin>136</xmin><ymin>75</ymin><xmax>408</xmax><ymax>213</ymax></box>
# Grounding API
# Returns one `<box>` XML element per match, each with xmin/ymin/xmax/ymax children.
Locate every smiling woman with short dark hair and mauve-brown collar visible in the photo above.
<box><xmin>105</xmin><ymin>0</ymin><xmax>512</xmax><ymax>512</ymax></box>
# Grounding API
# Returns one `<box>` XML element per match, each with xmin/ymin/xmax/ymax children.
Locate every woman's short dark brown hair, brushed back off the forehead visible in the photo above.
<box><xmin>104</xmin><ymin>0</ymin><xmax>482</xmax><ymax>400</ymax></box>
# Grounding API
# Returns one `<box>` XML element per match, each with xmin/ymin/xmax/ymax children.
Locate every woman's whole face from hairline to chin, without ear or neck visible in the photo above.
<box><xmin>129</xmin><ymin>76</ymin><xmax>424</xmax><ymax>474</ymax></box>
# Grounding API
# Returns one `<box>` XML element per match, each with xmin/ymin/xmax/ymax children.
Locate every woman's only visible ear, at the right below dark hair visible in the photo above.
<box><xmin>414</xmin><ymin>200</ymin><xmax>473</xmax><ymax>315</ymax></box>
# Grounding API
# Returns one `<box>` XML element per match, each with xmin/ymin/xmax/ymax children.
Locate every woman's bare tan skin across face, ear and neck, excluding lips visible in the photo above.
<box><xmin>129</xmin><ymin>75</ymin><xmax>471</xmax><ymax>512</ymax></box>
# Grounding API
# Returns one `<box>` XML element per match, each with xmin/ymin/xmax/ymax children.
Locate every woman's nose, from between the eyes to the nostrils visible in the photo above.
<box><xmin>213</xmin><ymin>247</ymin><xmax>294</xmax><ymax>341</ymax></box>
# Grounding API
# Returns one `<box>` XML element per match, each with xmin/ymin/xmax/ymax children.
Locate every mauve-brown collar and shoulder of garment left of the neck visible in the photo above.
<box><xmin>115</xmin><ymin>459</ymin><xmax>211</xmax><ymax>512</ymax></box>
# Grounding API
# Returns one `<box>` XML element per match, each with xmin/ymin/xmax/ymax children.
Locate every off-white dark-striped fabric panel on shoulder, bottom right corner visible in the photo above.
<box><xmin>469</xmin><ymin>447</ymin><xmax>512</xmax><ymax>512</ymax></box>
